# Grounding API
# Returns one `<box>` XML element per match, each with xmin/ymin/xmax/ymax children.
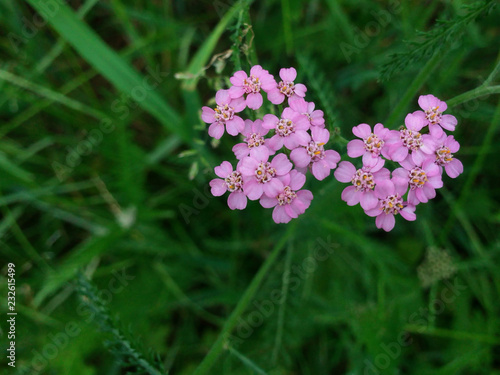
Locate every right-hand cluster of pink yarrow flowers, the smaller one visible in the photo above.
<box><xmin>334</xmin><ymin>95</ymin><xmax>463</xmax><ymax>232</ymax></box>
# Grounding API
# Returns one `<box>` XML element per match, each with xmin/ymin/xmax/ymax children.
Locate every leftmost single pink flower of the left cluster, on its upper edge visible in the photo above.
<box><xmin>201</xmin><ymin>90</ymin><xmax>245</xmax><ymax>139</ymax></box>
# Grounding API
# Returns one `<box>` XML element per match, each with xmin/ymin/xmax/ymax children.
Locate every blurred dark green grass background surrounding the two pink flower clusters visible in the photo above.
<box><xmin>0</xmin><ymin>0</ymin><xmax>500</xmax><ymax>375</ymax></box>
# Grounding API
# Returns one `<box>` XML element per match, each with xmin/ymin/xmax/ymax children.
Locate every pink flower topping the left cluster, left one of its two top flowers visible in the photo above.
<box><xmin>229</xmin><ymin>65</ymin><xmax>276</xmax><ymax>109</ymax></box>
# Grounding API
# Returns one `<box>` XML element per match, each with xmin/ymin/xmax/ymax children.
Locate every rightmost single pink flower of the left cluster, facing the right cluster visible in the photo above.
<box><xmin>290</xmin><ymin>127</ymin><xmax>340</xmax><ymax>180</ymax></box>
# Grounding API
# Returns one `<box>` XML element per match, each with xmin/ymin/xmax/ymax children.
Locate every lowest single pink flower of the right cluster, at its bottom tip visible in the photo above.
<box><xmin>365</xmin><ymin>180</ymin><xmax>417</xmax><ymax>232</ymax></box>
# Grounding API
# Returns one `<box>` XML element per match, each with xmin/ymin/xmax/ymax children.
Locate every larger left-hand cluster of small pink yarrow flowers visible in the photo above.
<box><xmin>201</xmin><ymin>65</ymin><xmax>340</xmax><ymax>223</ymax></box>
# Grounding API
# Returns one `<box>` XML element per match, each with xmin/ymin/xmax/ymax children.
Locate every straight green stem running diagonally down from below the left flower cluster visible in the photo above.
<box><xmin>193</xmin><ymin>222</ymin><xmax>296</xmax><ymax>375</ymax></box>
